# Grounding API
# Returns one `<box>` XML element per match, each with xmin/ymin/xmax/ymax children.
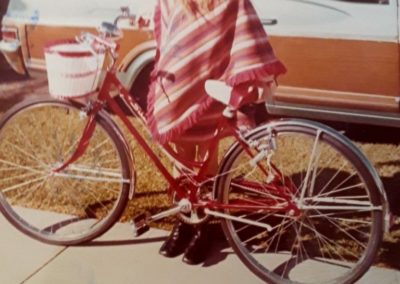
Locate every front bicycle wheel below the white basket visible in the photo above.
<box><xmin>0</xmin><ymin>100</ymin><xmax>131</xmax><ymax>245</ymax></box>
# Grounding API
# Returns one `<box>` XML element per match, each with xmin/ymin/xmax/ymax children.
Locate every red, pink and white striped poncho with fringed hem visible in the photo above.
<box><xmin>147</xmin><ymin>0</ymin><xmax>286</xmax><ymax>143</ymax></box>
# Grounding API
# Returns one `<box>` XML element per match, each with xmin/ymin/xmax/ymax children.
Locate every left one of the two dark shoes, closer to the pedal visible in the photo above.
<box><xmin>159</xmin><ymin>221</ymin><xmax>194</xmax><ymax>257</ymax></box>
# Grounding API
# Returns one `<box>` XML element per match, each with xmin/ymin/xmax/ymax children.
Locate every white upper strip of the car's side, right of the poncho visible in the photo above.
<box><xmin>252</xmin><ymin>0</ymin><xmax>398</xmax><ymax>42</ymax></box>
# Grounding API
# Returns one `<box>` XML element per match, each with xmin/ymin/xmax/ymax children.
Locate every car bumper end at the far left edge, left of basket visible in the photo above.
<box><xmin>0</xmin><ymin>40</ymin><xmax>28</xmax><ymax>75</ymax></box>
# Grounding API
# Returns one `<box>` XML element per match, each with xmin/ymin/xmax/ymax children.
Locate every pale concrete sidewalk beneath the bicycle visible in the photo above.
<box><xmin>0</xmin><ymin>213</ymin><xmax>400</xmax><ymax>284</ymax></box>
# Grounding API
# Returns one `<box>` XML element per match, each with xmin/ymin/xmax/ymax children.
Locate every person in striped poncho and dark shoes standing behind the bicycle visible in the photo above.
<box><xmin>147</xmin><ymin>0</ymin><xmax>286</xmax><ymax>264</ymax></box>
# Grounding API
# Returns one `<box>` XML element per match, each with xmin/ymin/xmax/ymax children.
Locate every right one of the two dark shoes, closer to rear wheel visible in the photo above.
<box><xmin>182</xmin><ymin>225</ymin><xmax>210</xmax><ymax>265</ymax></box>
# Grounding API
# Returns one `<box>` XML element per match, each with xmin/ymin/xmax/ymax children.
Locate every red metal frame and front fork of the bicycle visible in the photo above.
<box><xmin>53</xmin><ymin>67</ymin><xmax>297</xmax><ymax>215</ymax></box>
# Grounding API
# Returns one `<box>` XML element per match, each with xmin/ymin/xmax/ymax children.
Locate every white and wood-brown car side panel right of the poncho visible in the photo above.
<box><xmin>253</xmin><ymin>0</ymin><xmax>400</xmax><ymax>126</ymax></box>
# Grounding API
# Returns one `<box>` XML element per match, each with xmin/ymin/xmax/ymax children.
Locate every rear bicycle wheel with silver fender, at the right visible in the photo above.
<box><xmin>216</xmin><ymin>120</ymin><xmax>384</xmax><ymax>284</ymax></box>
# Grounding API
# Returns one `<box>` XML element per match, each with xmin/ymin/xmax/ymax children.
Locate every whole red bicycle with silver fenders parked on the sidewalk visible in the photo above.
<box><xmin>0</xmin><ymin>22</ymin><xmax>387</xmax><ymax>283</ymax></box>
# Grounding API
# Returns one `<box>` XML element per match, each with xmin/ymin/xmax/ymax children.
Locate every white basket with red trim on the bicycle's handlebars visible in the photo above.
<box><xmin>45</xmin><ymin>40</ymin><xmax>104</xmax><ymax>98</ymax></box>
